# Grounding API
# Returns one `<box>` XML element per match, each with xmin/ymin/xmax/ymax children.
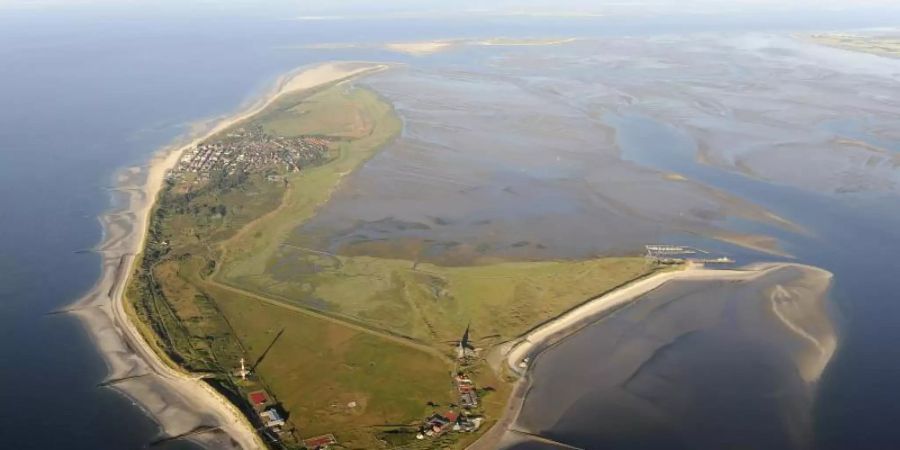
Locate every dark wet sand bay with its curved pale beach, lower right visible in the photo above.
<box><xmin>471</xmin><ymin>264</ymin><xmax>837</xmax><ymax>449</ymax></box>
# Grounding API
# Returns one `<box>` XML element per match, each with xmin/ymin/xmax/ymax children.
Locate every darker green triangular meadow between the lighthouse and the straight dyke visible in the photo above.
<box><xmin>209</xmin><ymin>287</ymin><xmax>453</xmax><ymax>448</ymax></box>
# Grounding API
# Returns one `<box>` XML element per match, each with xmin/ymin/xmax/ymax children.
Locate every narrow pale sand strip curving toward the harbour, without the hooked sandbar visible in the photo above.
<box><xmin>467</xmin><ymin>263</ymin><xmax>833</xmax><ymax>450</ymax></box>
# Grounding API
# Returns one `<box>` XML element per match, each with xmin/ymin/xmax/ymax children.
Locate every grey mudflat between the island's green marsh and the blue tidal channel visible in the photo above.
<box><xmin>292</xmin><ymin>67</ymin><xmax>782</xmax><ymax>264</ymax></box>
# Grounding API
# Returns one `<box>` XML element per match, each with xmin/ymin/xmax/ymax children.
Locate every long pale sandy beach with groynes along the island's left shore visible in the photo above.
<box><xmin>68</xmin><ymin>63</ymin><xmax>387</xmax><ymax>449</ymax></box>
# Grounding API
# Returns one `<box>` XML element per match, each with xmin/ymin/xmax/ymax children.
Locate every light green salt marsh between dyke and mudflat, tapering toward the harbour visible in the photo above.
<box><xmin>221</xmin><ymin>251</ymin><xmax>653</xmax><ymax>342</ymax></box>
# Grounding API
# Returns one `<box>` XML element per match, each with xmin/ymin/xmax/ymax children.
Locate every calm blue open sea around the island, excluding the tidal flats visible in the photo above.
<box><xmin>0</xmin><ymin>6</ymin><xmax>900</xmax><ymax>449</ymax></box>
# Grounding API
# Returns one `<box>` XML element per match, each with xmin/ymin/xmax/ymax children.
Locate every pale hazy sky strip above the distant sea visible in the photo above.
<box><xmin>0</xmin><ymin>0</ymin><xmax>900</xmax><ymax>34</ymax></box>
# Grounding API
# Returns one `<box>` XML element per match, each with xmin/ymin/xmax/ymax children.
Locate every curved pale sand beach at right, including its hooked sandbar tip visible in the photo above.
<box><xmin>469</xmin><ymin>263</ymin><xmax>836</xmax><ymax>450</ymax></box>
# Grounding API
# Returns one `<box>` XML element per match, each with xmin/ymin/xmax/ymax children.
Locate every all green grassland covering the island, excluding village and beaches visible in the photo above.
<box><xmin>127</xmin><ymin>79</ymin><xmax>655</xmax><ymax>448</ymax></box>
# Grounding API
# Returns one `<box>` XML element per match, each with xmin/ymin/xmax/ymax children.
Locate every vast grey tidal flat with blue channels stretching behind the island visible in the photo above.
<box><xmin>292</xmin><ymin>35</ymin><xmax>900</xmax><ymax>264</ymax></box>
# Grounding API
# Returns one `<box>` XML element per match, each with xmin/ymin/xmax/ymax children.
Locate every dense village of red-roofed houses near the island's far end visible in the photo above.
<box><xmin>172</xmin><ymin>125</ymin><xmax>329</xmax><ymax>180</ymax></box>
